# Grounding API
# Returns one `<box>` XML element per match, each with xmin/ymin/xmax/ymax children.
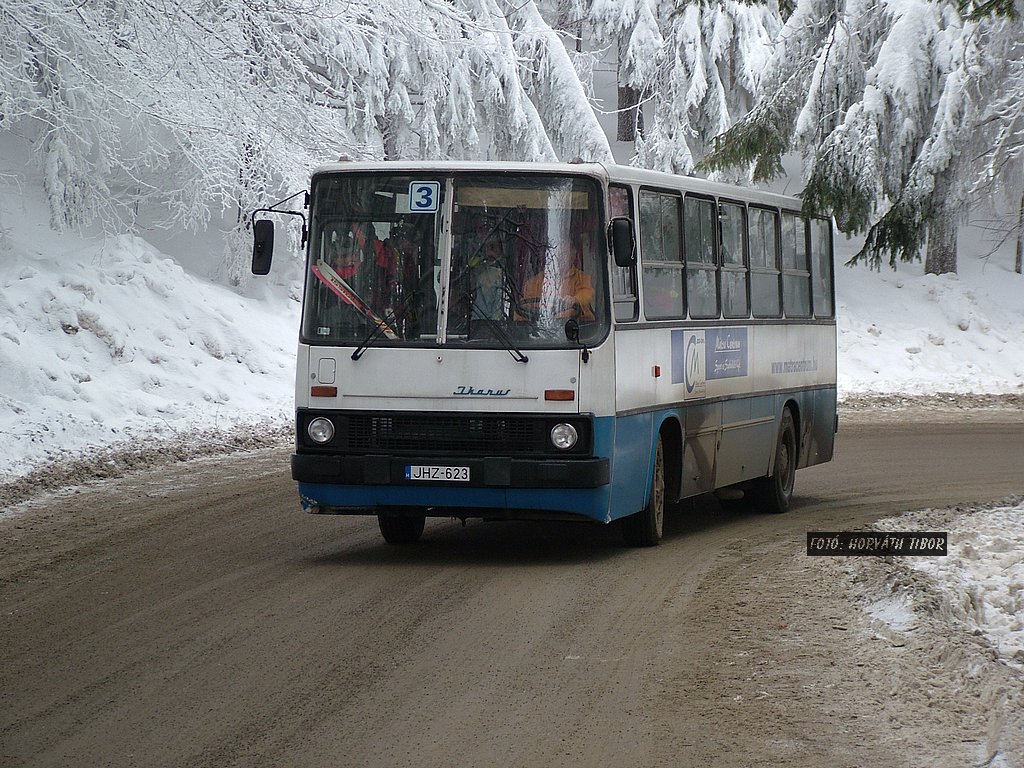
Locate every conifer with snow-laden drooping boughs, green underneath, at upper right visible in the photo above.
<box><xmin>706</xmin><ymin>0</ymin><xmax>1012</xmax><ymax>272</ymax></box>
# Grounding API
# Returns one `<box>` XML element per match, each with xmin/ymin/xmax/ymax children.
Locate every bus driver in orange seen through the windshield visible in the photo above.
<box><xmin>518</xmin><ymin>243</ymin><xmax>594</xmax><ymax>321</ymax></box>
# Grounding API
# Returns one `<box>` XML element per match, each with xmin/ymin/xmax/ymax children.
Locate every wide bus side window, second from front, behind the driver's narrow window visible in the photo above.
<box><xmin>640</xmin><ymin>189</ymin><xmax>686</xmax><ymax>319</ymax></box>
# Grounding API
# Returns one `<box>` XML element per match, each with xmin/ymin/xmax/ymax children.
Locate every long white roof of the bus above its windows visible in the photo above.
<box><xmin>312</xmin><ymin>160</ymin><xmax>802</xmax><ymax>210</ymax></box>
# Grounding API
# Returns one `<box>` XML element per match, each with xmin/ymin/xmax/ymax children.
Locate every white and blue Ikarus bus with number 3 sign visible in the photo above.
<box><xmin>253</xmin><ymin>162</ymin><xmax>837</xmax><ymax>546</ymax></box>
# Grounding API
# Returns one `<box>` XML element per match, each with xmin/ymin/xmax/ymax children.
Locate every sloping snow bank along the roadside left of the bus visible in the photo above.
<box><xmin>0</xmin><ymin>236</ymin><xmax>298</xmax><ymax>481</ymax></box>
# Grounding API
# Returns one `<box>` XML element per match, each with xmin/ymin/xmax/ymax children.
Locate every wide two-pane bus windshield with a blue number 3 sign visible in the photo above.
<box><xmin>302</xmin><ymin>173</ymin><xmax>609</xmax><ymax>349</ymax></box>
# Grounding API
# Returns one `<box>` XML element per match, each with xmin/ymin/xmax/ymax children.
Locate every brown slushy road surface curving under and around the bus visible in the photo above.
<box><xmin>0</xmin><ymin>413</ymin><xmax>1024</xmax><ymax>768</ymax></box>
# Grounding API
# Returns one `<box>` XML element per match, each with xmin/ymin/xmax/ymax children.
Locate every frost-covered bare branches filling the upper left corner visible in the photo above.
<box><xmin>0</xmin><ymin>0</ymin><xmax>364</xmax><ymax>228</ymax></box>
